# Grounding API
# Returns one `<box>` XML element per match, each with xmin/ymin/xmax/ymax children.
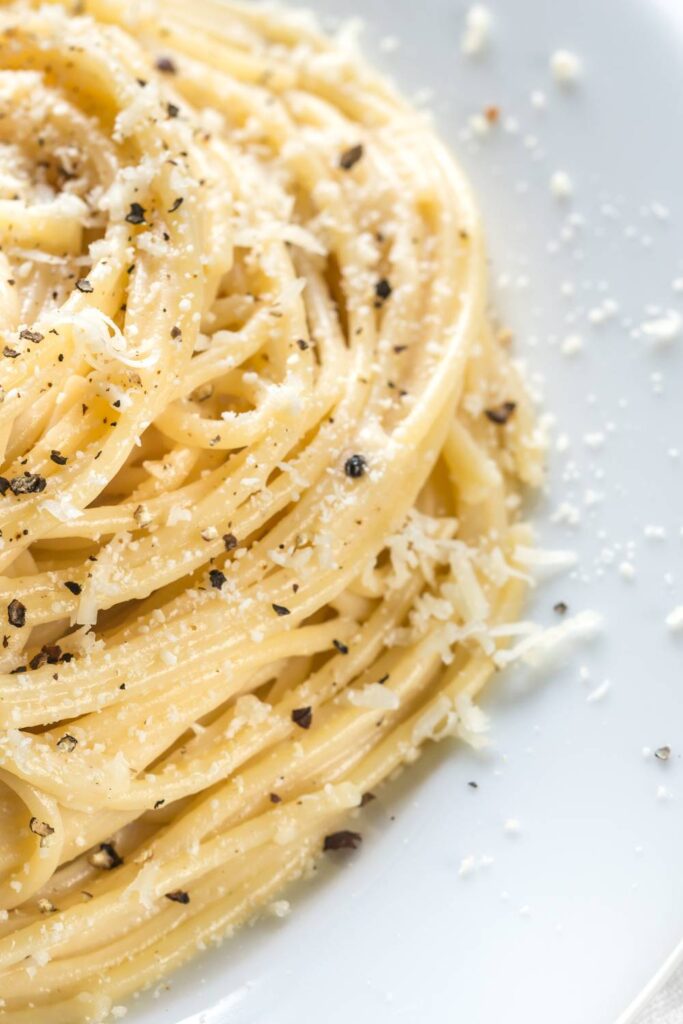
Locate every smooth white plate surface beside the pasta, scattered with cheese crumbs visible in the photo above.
<box><xmin>127</xmin><ymin>0</ymin><xmax>683</xmax><ymax>1024</ymax></box>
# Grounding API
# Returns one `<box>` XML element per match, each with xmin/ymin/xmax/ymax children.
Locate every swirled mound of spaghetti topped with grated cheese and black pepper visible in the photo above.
<box><xmin>0</xmin><ymin>0</ymin><xmax>543</xmax><ymax>1024</ymax></box>
